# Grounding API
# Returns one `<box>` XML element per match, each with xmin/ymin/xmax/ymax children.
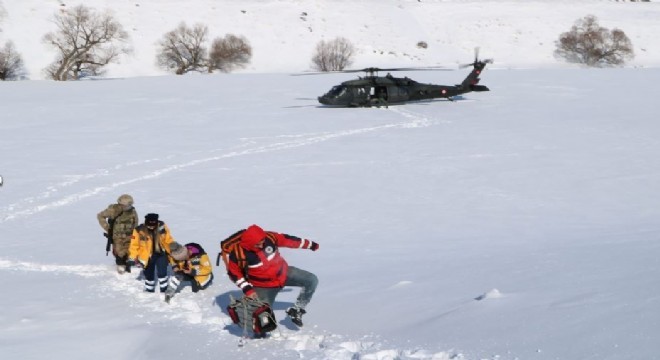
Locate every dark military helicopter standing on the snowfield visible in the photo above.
<box><xmin>318</xmin><ymin>48</ymin><xmax>493</xmax><ymax>107</ymax></box>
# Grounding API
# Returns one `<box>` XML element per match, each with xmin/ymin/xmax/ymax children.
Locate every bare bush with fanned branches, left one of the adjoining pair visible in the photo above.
<box><xmin>156</xmin><ymin>22</ymin><xmax>209</xmax><ymax>75</ymax></box>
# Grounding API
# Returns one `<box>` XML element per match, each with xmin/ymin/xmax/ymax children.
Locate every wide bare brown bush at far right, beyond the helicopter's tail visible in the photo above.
<box><xmin>555</xmin><ymin>15</ymin><xmax>635</xmax><ymax>66</ymax></box>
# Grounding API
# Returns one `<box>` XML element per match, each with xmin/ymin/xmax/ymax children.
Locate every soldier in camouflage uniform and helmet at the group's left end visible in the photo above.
<box><xmin>96</xmin><ymin>194</ymin><xmax>139</xmax><ymax>274</ymax></box>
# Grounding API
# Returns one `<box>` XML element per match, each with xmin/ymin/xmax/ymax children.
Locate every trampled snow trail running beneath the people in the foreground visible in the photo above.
<box><xmin>0</xmin><ymin>259</ymin><xmax>462</xmax><ymax>360</ymax></box>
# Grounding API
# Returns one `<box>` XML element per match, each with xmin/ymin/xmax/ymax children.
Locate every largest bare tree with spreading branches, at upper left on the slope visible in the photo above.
<box><xmin>43</xmin><ymin>5</ymin><xmax>131</xmax><ymax>81</ymax></box>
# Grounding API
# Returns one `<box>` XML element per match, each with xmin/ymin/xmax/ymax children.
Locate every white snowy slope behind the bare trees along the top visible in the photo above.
<box><xmin>0</xmin><ymin>0</ymin><xmax>660</xmax><ymax>79</ymax></box>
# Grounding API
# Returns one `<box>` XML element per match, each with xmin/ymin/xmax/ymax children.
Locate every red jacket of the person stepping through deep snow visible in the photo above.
<box><xmin>227</xmin><ymin>231</ymin><xmax>313</xmax><ymax>295</ymax></box>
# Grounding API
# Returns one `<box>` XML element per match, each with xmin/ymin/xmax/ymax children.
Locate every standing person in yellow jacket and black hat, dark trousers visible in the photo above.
<box><xmin>128</xmin><ymin>213</ymin><xmax>174</xmax><ymax>293</ymax></box>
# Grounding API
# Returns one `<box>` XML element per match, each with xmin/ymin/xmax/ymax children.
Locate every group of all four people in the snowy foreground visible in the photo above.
<box><xmin>97</xmin><ymin>194</ymin><xmax>319</xmax><ymax>326</ymax></box>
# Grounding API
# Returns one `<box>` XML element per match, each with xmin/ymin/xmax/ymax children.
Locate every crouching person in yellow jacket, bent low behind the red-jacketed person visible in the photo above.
<box><xmin>165</xmin><ymin>242</ymin><xmax>213</xmax><ymax>303</ymax></box>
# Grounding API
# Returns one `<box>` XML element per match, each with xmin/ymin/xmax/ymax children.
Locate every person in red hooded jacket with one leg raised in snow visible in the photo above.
<box><xmin>227</xmin><ymin>225</ymin><xmax>319</xmax><ymax>326</ymax></box>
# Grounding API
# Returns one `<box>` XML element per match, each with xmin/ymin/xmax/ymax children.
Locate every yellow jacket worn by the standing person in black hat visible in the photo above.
<box><xmin>128</xmin><ymin>221</ymin><xmax>174</xmax><ymax>267</ymax></box>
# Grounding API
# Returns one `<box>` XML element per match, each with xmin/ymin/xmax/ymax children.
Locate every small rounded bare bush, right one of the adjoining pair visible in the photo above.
<box><xmin>209</xmin><ymin>34</ymin><xmax>252</xmax><ymax>72</ymax></box>
